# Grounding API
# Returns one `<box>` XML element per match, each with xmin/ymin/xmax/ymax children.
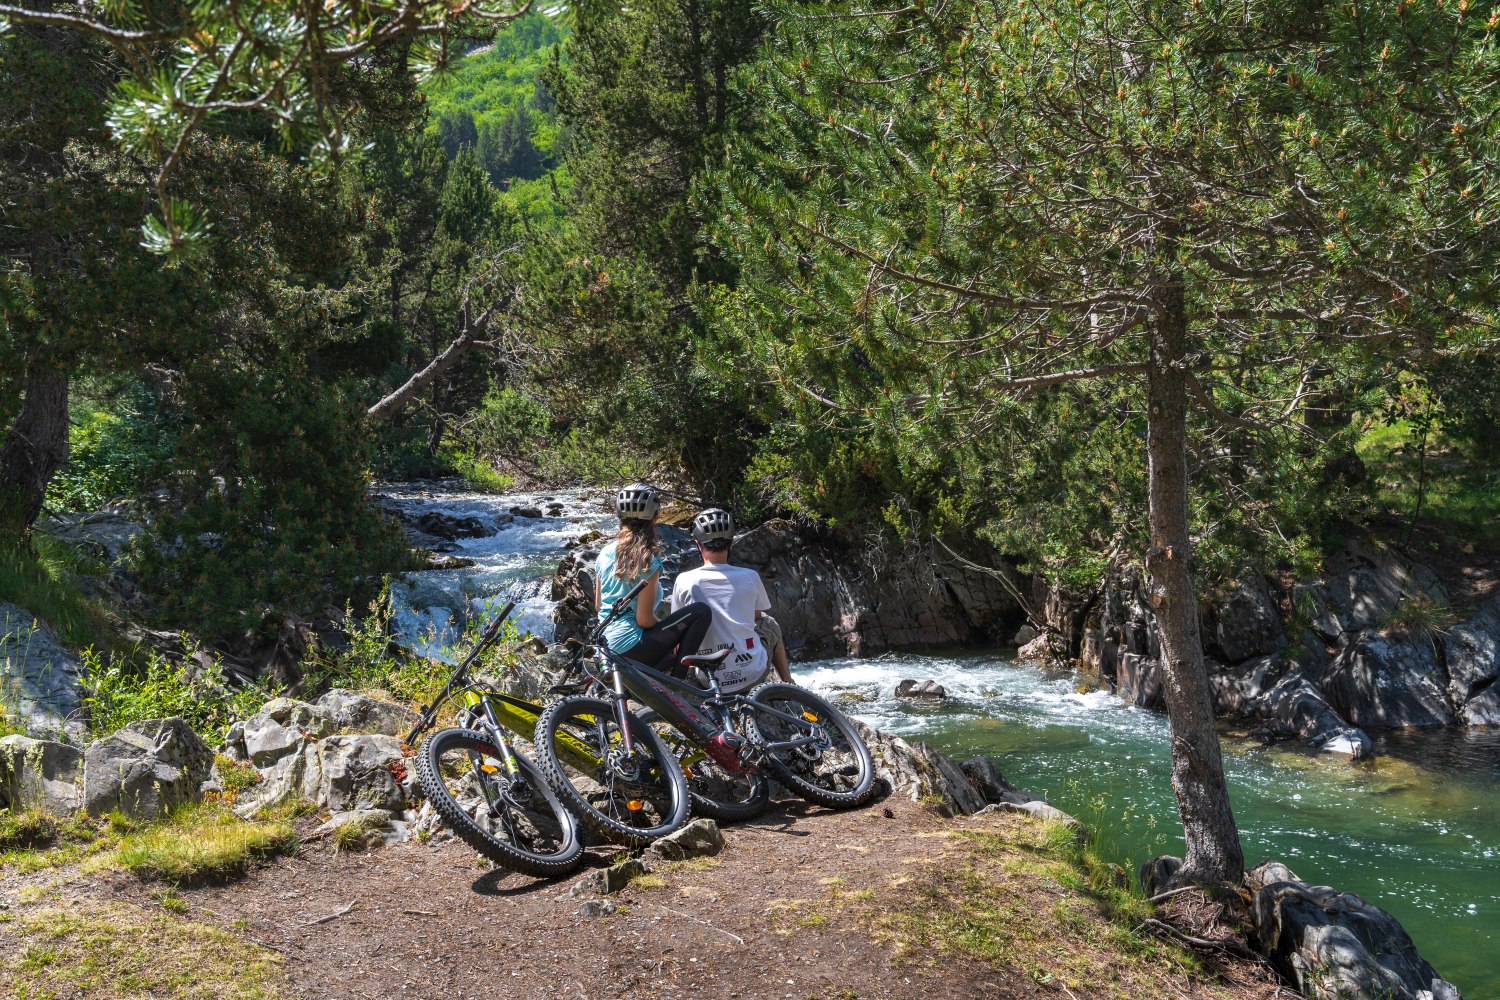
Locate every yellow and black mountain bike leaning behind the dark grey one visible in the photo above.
<box><xmin>407</xmin><ymin>601</ymin><xmax>588</xmax><ymax>877</ymax></box>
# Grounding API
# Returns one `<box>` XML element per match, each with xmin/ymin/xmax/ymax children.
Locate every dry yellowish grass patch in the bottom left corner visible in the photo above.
<box><xmin>0</xmin><ymin>901</ymin><xmax>288</xmax><ymax>1000</ymax></box>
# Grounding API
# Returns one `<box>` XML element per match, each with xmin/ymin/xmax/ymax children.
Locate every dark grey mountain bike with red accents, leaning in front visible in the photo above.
<box><xmin>537</xmin><ymin>586</ymin><xmax>875</xmax><ymax>825</ymax></box>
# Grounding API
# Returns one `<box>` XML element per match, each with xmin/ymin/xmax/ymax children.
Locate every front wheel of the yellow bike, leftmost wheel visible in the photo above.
<box><xmin>417</xmin><ymin>729</ymin><xmax>584</xmax><ymax>879</ymax></box>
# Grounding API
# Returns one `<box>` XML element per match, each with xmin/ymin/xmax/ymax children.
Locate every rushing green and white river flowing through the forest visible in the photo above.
<box><xmin>383</xmin><ymin>487</ymin><xmax>1500</xmax><ymax>1000</ymax></box>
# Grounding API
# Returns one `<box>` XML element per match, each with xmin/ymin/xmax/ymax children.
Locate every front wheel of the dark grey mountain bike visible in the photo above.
<box><xmin>534</xmin><ymin>696</ymin><xmax>689</xmax><ymax>847</ymax></box>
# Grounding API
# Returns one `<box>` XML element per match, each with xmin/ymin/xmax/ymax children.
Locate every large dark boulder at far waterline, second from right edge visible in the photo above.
<box><xmin>1323</xmin><ymin>630</ymin><xmax>1454</xmax><ymax>729</ymax></box>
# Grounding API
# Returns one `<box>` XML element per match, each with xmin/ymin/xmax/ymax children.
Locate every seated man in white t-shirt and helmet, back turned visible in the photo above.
<box><xmin>672</xmin><ymin>507</ymin><xmax>792</xmax><ymax>694</ymax></box>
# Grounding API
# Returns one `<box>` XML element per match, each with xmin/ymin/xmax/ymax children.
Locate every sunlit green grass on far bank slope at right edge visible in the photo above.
<box><xmin>1355</xmin><ymin>421</ymin><xmax>1500</xmax><ymax>546</ymax></box>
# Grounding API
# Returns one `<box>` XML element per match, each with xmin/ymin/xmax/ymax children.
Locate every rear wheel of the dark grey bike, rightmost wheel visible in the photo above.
<box><xmin>746</xmin><ymin>681</ymin><xmax>875</xmax><ymax>810</ymax></box>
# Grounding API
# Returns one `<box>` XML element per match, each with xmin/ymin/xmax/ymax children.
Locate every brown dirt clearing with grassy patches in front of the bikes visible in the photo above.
<box><xmin>0</xmin><ymin>801</ymin><xmax>1286</xmax><ymax>1000</ymax></box>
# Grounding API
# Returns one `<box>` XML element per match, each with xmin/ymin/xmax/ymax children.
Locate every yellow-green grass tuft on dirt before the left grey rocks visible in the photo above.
<box><xmin>114</xmin><ymin>805</ymin><xmax>297</xmax><ymax>882</ymax></box>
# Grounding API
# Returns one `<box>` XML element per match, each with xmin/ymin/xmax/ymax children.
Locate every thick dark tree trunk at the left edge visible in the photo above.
<box><xmin>0</xmin><ymin>361</ymin><xmax>68</xmax><ymax>534</ymax></box>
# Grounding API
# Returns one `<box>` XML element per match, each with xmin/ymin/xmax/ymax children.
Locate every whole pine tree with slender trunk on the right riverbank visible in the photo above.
<box><xmin>720</xmin><ymin>0</ymin><xmax>1500</xmax><ymax>882</ymax></box>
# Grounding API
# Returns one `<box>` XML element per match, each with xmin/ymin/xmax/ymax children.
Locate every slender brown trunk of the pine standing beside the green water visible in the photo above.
<box><xmin>1146</xmin><ymin>286</ymin><xmax>1245</xmax><ymax>883</ymax></box>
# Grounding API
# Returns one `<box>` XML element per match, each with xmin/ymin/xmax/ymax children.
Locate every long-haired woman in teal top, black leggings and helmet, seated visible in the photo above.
<box><xmin>594</xmin><ymin>483</ymin><xmax>714</xmax><ymax>676</ymax></box>
